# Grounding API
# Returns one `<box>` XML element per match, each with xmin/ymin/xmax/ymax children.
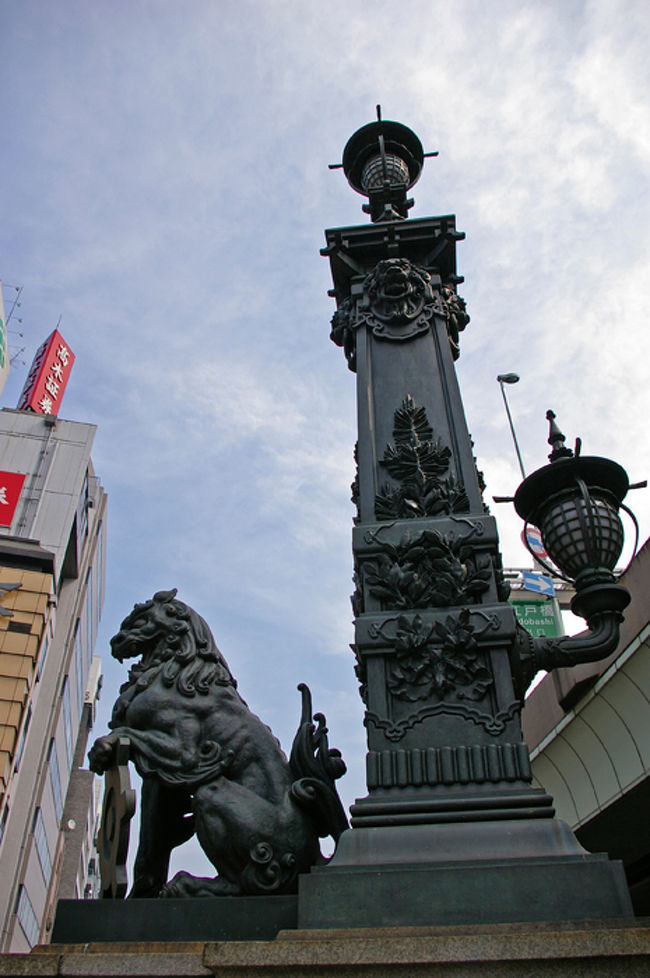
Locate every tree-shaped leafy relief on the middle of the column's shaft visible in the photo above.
<box><xmin>375</xmin><ymin>394</ymin><xmax>469</xmax><ymax>520</ymax></box>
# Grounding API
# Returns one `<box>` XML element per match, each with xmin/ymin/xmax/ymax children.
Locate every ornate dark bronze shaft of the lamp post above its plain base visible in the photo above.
<box><xmin>325</xmin><ymin>114</ymin><xmax>540</xmax><ymax>828</ymax></box>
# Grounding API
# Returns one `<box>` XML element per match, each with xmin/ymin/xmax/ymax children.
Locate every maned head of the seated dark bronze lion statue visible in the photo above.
<box><xmin>111</xmin><ymin>588</ymin><xmax>236</xmax><ymax>696</ymax></box>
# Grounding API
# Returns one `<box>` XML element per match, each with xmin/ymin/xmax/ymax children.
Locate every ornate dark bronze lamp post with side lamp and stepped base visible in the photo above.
<box><xmin>299</xmin><ymin>115</ymin><xmax>631</xmax><ymax>927</ymax></box>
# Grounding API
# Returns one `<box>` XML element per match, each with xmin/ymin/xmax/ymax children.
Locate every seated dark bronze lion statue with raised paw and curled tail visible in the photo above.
<box><xmin>88</xmin><ymin>589</ymin><xmax>347</xmax><ymax>897</ymax></box>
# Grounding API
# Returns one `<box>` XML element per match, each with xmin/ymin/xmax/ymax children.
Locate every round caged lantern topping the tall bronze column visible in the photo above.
<box><xmin>330</xmin><ymin>105</ymin><xmax>438</xmax><ymax>223</ymax></box>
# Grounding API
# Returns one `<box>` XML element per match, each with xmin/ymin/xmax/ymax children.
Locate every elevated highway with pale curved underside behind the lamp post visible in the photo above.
<box><xmin>522</xmin><ymin>540</ymin><xmax>650</xmax><ymax>917</ymax></box>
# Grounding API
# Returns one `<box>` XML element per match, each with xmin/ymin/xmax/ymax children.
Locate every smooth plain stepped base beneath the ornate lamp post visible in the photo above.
<box><xmin>298</xmin><ymin>818</ymin><xmax>633</xmax><ymax>928</ymax></box>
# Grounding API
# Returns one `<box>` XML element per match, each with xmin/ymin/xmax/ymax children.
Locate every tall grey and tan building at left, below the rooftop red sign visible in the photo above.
<box><xmin>0</xmin><ymin>409</ymin><xmax>106</xmax><ymax>952</ymax></box>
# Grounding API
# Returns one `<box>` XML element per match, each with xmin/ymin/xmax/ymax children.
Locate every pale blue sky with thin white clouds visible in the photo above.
<box><xmin>0</xmin><ymin>0</ymin><xmax>650</xmax><ymax>869</ymax></box>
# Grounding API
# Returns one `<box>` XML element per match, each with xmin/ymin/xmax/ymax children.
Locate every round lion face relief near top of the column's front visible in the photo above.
<box><xmin>365</xmin><ymin>258</ymin><xmax>433</xmax><ymax>322</ymax></box>
